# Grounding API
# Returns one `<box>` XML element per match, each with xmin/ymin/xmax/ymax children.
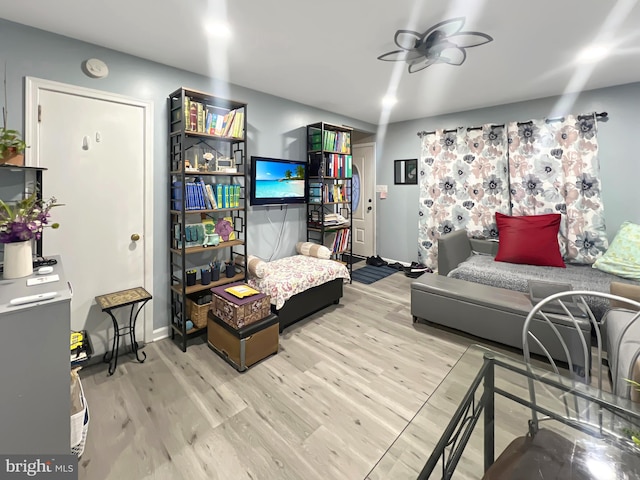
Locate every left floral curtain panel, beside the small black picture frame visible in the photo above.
<box><xmin>418</xmin><ymin>125</ymin><xmax>509</xmax><ymax>269</ymax></box>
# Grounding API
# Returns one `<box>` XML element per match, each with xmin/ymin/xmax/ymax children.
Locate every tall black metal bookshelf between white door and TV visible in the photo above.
<box><xmin>168</xmin><ymin>88</ymin><xmax>247</xmax><ymax>351</ymax></box>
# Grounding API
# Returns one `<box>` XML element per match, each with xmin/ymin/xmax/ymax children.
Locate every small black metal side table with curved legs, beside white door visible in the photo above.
<box><xmin>96</xmin><ymin>287</ymin><xmax>152</xmax><ymax>375</ymax></box>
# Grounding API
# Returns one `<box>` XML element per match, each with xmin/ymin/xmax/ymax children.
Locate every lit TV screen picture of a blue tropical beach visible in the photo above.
<box><xmin>254</xmin><ymin>159</ymin><xmax>306</xmax><ymax>202</ymax></box>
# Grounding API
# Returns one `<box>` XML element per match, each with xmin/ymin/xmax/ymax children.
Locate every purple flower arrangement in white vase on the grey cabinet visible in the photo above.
<box><xmin>0</xmin><ymin>191</ymin><xmax>59</xmax><ymax>279</ymax></box>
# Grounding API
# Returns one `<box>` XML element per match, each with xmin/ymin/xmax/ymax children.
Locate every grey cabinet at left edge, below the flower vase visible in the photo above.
<box><xmin>0</xmin><ymin>257</ymin><xmax>71</xmax><ymax>455</ymax></box>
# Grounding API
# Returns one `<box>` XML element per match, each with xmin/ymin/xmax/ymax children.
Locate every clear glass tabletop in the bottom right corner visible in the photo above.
<box><xmin>366</xmin><ymin>345</ymin><xmax>640</xmax><ymax>480</ymax></box>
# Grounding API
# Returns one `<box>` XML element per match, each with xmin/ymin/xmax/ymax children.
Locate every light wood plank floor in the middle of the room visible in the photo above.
<box><xmin>79</xmin><ymin>273</ymin><xmax>477</xmax><ymax>480</ymax></box>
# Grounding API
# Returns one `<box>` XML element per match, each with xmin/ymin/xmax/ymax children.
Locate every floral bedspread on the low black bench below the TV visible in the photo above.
<box><xmin>248</xmin><ymin>255</ymin><xmax>349</xmax><ymax>310</ymax></box>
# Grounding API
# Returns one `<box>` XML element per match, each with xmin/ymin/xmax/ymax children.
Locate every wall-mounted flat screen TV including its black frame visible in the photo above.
<box><xmin>250</xmin><ymin>156</ymin><xmax>307</xmax><ymax>205</ymax></box>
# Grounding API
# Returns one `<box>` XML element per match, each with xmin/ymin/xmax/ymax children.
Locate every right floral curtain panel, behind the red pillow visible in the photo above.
<box><xmin>507</xmin><ymin>114</ymin><xmax>608</xmax><ymax>264</ymax></box>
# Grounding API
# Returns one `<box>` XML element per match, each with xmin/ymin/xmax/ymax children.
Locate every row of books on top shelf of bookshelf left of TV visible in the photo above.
<box><xmin>184</xmin><ymin>97</ymin><xmax>244</xmax><ymax>138</ymax></box>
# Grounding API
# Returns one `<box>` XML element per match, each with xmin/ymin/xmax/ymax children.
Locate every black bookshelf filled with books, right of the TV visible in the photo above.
<box><xmin>307</xmin><ymin>122</ymin><xmax>353</xmax><ymax>282</ymax></box>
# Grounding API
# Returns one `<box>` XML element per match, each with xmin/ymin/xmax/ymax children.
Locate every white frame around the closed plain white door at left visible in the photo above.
<box><xmin>24</xmin><ymin>77</ymin><xmax>154</xmax><ymax>343</ymax></box>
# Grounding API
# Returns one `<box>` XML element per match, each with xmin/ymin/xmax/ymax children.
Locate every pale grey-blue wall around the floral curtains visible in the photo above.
<box><xmin>376</xmin><ymin>83</ymin><xmax>640</xmax><ymax>261</ymax></box>
